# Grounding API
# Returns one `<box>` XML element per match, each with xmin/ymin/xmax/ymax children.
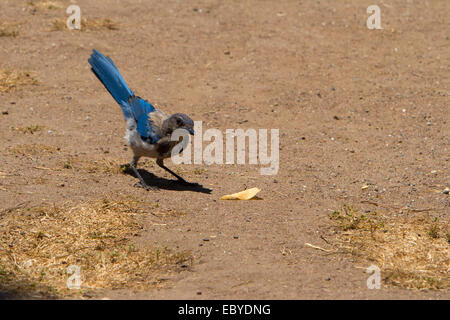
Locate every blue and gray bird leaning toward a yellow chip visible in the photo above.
<box><xmin>88</xmin><ymin>50</ymin><xmax>194</xmax><ymax>190</ymax></box>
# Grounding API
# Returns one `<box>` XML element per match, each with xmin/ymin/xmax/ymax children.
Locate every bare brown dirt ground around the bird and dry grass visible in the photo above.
<box><xmin>0</xmin><ymin>0</ymin><xmax>450</xmax><ymax>299</ymax></box>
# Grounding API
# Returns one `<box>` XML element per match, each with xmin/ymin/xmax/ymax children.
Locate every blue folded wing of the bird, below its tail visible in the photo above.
<box><xmin>128</xmin><ymin>96</ymin><xmax>161</xmax><ymax>143</ymax></box>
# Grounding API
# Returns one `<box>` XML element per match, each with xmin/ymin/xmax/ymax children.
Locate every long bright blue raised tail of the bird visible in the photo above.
<box><xmin>88</xmin><ymin>50</ymin><xmax>134</xmax><ymax>119</ymax></box>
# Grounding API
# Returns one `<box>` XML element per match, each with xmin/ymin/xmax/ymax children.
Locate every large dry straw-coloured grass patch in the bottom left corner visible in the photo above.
<box><xmin>0</xmin><ymin>199</ymin><xmax>191</xmax><ymax>296</ymax></box>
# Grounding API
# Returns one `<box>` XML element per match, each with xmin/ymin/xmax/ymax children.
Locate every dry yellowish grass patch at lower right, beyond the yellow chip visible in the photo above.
<box><xmin>330</xmin><ymin>205</ymin><xmax>450</xmax><ymax>289</ymax></box>
